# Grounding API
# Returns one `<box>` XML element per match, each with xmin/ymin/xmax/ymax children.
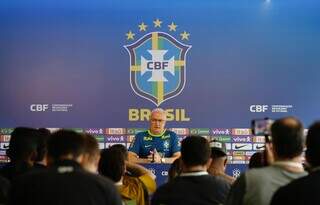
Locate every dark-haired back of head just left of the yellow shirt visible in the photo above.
<box><xmin>98</xmin><ymin>148</ymin><xmax>125</xmax><ymax>182</ymax></box>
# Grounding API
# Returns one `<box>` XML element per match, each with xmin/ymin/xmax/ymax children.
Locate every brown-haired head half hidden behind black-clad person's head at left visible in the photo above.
<box><xmin>81</xmin><ymin>134</ymin><xmax>100</xmax><ymax>173</ymax></box>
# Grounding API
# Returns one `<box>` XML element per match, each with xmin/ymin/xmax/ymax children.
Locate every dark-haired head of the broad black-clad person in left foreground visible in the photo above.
<box><xmin>48</xmin><ymin>130</ymin><xmax>85</xmax><ymax>161</ymax></box>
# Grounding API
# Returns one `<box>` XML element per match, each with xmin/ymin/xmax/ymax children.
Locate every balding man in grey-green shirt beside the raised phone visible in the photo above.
<box><xmin>226</xmin><ymin>117</ymin><xmax>307</xmax><ymax>205</ymax></box>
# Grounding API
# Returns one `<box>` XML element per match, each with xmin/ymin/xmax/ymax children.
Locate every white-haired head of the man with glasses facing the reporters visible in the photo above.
<box><xmin>150</xmin><ymin>108</ymin><xmax>167</xmax><ymax>135</ymax></box>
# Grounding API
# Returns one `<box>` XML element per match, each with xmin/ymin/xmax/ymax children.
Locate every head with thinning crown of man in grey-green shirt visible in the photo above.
<box><xmin>271</xmin><ymin>117</ymin><xmax>305</xmax><ymax>159</ymax></box>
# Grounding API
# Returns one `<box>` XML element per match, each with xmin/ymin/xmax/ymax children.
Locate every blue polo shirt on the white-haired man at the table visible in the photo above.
<box><xmin>129</xmin><ymin>130</ymin><xmax>180</xmax><ymax>158</ymax></box>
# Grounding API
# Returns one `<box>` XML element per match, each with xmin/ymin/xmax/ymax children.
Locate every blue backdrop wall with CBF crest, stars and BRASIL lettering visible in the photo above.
<box><xmin>0</xmin><ymin>0</ymin><xmax>320</xmax><ymax>181</ymax></box>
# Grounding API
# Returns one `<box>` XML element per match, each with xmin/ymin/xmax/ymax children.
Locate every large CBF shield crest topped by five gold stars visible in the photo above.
<box><xmin>124</xmin><ymin>19</ymin><xmax>191</xmax><ymax>106</ymax></box>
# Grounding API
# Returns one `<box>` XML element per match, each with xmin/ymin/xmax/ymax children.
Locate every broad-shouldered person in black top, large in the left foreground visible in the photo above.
<box><xmin>9</xmin><ymin>130</ymin><xmax>121</xmax><ymax>205</ymax></box>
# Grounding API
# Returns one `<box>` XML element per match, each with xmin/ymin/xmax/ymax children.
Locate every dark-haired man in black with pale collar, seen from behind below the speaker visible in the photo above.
<box><xmin>151</xmin><ymin>136</ymin><xmax>230</xmax><ymax>205</ymax></box>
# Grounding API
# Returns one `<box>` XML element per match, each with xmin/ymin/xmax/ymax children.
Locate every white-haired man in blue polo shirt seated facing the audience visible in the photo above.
<box><xmin>129</xmin><ymin>108</ymin><xmax>180</xmax><ymax>163</ymax></box>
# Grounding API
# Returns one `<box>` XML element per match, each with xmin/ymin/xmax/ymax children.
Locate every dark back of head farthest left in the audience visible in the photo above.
<box><xmin>7</xmin><ymin>127</ymin><xmax>38</xmax><ymax>162</ymax></box>
